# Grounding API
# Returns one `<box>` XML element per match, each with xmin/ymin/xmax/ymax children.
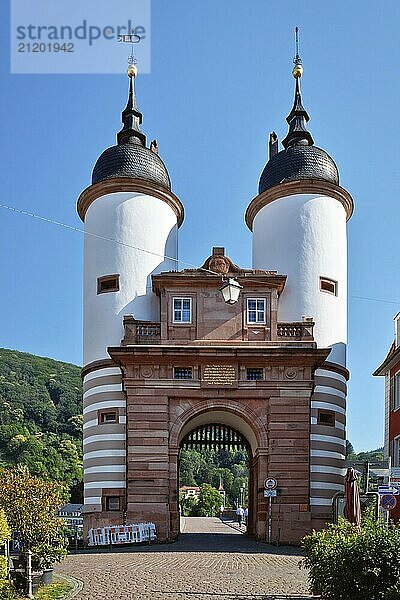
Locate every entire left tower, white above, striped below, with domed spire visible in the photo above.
<box><xmin>78</xmin><ymin>67</ymin><xmax>183</xmax><ymax>527</ymax></box>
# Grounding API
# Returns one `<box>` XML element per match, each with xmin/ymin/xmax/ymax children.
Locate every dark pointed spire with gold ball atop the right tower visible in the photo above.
<box><xmin>282</xmin><ymin>27</ymin><xmax>314</xmax><ymax>148</ymax></box>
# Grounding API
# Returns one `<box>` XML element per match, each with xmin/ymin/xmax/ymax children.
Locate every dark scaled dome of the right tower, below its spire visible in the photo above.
<box><xmin>258</xmin><ymin>145</ymin><xmax>339</xmax><ymax>194</ymax></box>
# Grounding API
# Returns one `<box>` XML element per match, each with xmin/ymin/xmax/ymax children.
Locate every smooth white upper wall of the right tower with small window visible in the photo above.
<box><xmin>253</xmin><ymin>194</ymin><xmax>347</xmax><ymax>365</ymax></box>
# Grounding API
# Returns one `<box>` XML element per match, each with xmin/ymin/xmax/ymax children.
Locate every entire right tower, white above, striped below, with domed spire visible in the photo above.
<box><xmin>246</xmin><ymin>54</ymin><xmax>353</xmax><ymax>520</ymax></box>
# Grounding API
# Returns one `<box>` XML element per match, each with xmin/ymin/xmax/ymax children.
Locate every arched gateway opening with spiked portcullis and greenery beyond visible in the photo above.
<box><xmin>177</xmin><ymin>410</ymin><xmax>258</xmax><ymax>535</ymax></box>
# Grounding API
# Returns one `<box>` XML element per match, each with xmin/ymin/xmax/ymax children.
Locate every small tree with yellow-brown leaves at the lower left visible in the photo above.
<box><xmin>0</xmin><ymin>466</ymin><xmax>65</xmax><ymax>562</ymax></box>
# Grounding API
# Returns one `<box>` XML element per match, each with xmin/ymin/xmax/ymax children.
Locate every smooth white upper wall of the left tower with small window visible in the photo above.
<box><xmin>83</xmin><ymin>192</ymin><xmax>177</xmax><ymax>365</ymax></box>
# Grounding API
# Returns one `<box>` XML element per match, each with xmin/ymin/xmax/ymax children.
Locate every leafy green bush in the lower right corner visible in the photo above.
<box><xmin>302</xmin><ymin>517</ymin><xmax>400</xmax><ymax>600</ymax></box>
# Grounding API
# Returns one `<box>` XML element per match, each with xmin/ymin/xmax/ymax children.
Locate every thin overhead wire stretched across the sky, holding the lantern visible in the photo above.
<box><xmin>0</xmin><ymin>204</ymin><xmax>400</xmax><ymax>306</ymax></box>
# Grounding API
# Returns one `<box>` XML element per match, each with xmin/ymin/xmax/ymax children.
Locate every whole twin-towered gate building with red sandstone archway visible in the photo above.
<box><xmin>78</xmin><ymin>52</ymin><xmax>353</xmax><ymax>542</ymax></box>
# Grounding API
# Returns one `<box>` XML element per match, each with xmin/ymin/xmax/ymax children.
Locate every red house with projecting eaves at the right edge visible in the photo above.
<box><xmin>374</xmin><ymin>313</ymin><xmax>400</xmax><ymax>521</ymax></box>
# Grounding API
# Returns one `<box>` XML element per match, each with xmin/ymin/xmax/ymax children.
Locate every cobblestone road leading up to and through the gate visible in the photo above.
<box><xmin>57</xmin><ymin>518</ymin><xmax>307</xmax><ymax>600</ymax></box>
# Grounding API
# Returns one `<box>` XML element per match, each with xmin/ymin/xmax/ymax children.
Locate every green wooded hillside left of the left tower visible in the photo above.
<box><xmin>0</xmin><ymin>348</ymin><xmax>82</xmax><ymax>486</ymax></box>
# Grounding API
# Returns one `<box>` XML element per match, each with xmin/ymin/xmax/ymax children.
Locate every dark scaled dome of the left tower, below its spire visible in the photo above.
<box><xmin>92</xmin><ymin>142</ymin><xmax>171</xmax><ymax>190</ymax></box>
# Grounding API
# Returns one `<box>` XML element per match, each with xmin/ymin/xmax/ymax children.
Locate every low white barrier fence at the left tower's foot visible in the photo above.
<box><xmin>88</xmin><ymin>523</ymin><xmax>156</xmax><ymax>546</ymax></box>
